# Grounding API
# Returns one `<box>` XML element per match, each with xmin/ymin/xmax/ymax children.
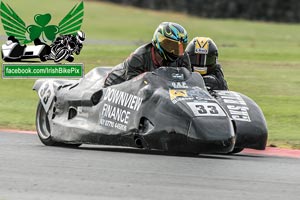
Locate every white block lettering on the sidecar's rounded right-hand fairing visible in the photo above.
<box><xmin>218</xmin><ymin>91</ymin><xmax>251</xmax><ymax>122</ymax></box>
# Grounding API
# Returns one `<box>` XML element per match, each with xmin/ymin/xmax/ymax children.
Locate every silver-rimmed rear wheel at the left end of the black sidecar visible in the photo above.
<box><xmin>37</xmin><ymin>104</ymin><xmax>51</xmax><ymax>139</ymax></box>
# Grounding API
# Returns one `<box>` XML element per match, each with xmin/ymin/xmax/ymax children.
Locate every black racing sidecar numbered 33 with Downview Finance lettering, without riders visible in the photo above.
<box><xmin>33</xmin><ymin>67</ymin><xmax>267</xmax><ymax>154</ymax></box>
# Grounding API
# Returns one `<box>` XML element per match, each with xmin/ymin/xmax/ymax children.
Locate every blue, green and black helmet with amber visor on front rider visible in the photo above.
<box><xmin>152</xmin><ymin>22</ymin><xmax>188</xmax><ymax>61</ymax></box>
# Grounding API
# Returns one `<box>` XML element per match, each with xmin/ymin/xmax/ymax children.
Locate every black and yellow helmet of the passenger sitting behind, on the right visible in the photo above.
<box><xmin>185</xmin><ymin>37</ymin><xmax>218</xmax><ymax>75</ymax></box>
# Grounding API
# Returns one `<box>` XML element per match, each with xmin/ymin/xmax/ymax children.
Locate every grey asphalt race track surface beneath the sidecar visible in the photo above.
<box><xmin>0</xmin><ymin>131</ymin><xmax>300</xmax><ymax>200</ymax></box>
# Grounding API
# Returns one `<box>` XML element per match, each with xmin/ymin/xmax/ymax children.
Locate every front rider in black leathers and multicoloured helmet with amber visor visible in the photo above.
<box><xmin>104</xmin><ymin>22</ymin><xmax>192</xmax><ymax>87</ymax></box>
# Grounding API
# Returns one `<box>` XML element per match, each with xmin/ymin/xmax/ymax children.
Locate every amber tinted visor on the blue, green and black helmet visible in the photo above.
<box><xmin>160</xmin><ymin>38</ymin><xmax>187</xmax><ymax>56</ymax></box>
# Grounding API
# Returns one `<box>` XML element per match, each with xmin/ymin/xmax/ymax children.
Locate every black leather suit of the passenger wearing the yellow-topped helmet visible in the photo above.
<box><xmin>203</xmin><ymin>64</ymin><xmax>228</xmax><ymax>90</ymax></box>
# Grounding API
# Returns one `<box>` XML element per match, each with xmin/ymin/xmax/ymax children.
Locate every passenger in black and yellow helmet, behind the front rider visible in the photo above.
<box><xmin>186</xmin><ymin>37</ymin><xmax>228</xmax><ymax>90</ymax></box>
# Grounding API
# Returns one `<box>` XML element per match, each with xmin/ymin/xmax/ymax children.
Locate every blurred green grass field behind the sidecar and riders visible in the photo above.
<box><xmin>0</xmin><ymin>0</ymin><xmax>300</xmax><ymax>148</ymax></box>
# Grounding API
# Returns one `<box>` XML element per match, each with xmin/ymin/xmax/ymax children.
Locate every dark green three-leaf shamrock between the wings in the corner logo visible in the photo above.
<box><xmin>26</xmin><ymin>13</ymin><xmax>59</xmax><ymax>42</ymax></box>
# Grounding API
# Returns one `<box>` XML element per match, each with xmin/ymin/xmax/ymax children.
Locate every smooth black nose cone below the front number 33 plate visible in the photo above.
<box><xmin>187</xmin><ymin>117</ymin><xmax>236</xmax><ymax>153</ymax></box>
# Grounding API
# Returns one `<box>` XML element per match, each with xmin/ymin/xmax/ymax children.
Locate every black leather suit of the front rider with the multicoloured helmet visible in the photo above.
<box><xmin>104</xmin><ymin>43</ymin><xmax>192</xmax><ymax>87</ymax></box>
